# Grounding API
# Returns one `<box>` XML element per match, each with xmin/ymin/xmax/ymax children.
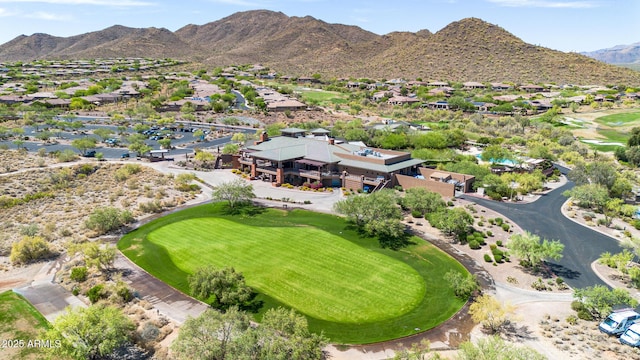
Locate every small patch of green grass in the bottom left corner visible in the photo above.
<box><xmin>0</xmin><ymin>291</ymin><xmax>56</xmax><ymax>359</ymax></box>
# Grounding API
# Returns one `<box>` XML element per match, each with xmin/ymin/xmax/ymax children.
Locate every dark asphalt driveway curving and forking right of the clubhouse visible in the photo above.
<box><xmin>461</xmin><ymin>175</ymin><xmax>622</xmax><ymax>289</ymax></box>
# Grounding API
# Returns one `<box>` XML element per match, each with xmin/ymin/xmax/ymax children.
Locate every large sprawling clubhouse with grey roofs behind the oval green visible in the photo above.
<box><xmin>238</xmin><ymin>129</ymin><xmax>423</xmax><ymax>191</ymax></box>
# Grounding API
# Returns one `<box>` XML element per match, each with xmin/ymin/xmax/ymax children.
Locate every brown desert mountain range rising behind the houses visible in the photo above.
<box><xmin>0</xmin><ymin>10</ymin><xmax>640</xmax><ymax>84</ymax></box>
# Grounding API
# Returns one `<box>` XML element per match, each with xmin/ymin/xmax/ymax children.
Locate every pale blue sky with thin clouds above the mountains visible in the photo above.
<box><xmin>0</xmin><ymin>0</ymin><xmax>640</xmax><ymax>51</ymax></box>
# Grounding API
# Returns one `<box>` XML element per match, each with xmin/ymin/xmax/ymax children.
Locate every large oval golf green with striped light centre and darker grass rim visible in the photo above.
<box><xmin>118</xmin><ymin>204</ymin><xmax>466</xmax><ymax>343</ymax></box>
